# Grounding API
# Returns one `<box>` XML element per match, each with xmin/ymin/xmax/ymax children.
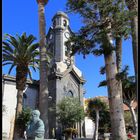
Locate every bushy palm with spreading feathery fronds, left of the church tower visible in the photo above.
<box><xmin>2</xmin><ymin>33</ymin><xmax>39</xmax><ymax>138</ymax></box>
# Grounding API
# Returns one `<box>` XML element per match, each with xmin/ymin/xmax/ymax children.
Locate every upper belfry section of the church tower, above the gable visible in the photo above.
<box><xmin>47</xmin><ymin>11</ymin><xmax>74</xmax><ymax>72</ymax></box>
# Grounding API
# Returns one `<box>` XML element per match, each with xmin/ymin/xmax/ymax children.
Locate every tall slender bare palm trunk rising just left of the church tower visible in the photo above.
<box><xmin>38</xmin><ymin>3</ymin><xmax>49</xmax><ymax>138</ymax></box>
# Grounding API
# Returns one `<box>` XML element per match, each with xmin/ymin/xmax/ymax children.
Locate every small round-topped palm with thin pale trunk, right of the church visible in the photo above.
<box><xmin>87</xmin><ymin>97</ymin><xmax>107</xmax><ymax>140</ymax></box>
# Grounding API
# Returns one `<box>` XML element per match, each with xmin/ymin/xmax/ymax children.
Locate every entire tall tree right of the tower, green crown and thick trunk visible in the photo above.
<box><xmin>66</xmin><ymin>0</ymin><xmax>131</xmax><ymax>140</ymax></box>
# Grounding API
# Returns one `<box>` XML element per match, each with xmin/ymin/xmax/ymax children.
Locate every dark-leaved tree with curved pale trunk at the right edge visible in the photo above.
<box><xmin>99</xmin><ymin>66</ymin><xmax>137</xmax><ymax>133</ymax></box>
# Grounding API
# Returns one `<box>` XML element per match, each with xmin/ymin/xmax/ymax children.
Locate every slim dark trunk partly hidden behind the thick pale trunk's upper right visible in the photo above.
<box><xmin>116</xmin><ymin>37</ymin><xmax>122</xmax><ymax>72</ymax></box>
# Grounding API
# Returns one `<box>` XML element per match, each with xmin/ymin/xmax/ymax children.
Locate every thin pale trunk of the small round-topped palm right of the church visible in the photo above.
<box><xmin>93</xmin><ymin>110</ymin><xmax>99</xmax><ymax>140</ymax></box>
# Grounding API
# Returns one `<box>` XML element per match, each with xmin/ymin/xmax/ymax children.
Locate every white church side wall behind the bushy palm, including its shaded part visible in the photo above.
<box><xmin>2</xmin><ymin>82</ymin><xmax>38</xmax><ymax>140</ymax></box>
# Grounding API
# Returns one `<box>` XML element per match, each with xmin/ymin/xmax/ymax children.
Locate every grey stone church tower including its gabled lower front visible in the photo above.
<box><xmin>46</xmin><ymin>11</ymin><xmax>85</xmax><ymax>136</ymax></box>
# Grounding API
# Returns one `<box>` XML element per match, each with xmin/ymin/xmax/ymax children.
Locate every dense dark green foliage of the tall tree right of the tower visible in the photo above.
<box><xmin>67</xmin><ymin>0</ymin><xmax>131</xmax><ymax>56</ymax></box>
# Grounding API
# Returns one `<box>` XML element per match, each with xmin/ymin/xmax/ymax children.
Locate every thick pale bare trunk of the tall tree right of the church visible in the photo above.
<box><xmin>104</xmin><ymin>52</ymin><xmax>127</xmax><ymax>140</ymax></box>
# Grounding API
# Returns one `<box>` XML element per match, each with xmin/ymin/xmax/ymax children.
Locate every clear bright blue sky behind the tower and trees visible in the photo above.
<box><xmin>2</xmin><ymin>0</ymin><xmax>134</xmax><ymax>98</ymax></box>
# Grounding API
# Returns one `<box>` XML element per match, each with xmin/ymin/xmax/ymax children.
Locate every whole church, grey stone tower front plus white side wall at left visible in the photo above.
<box><xmin>3</xmin><ymin>11</ymin><xmax>85</xmax><ymax>138</ymax></box>
